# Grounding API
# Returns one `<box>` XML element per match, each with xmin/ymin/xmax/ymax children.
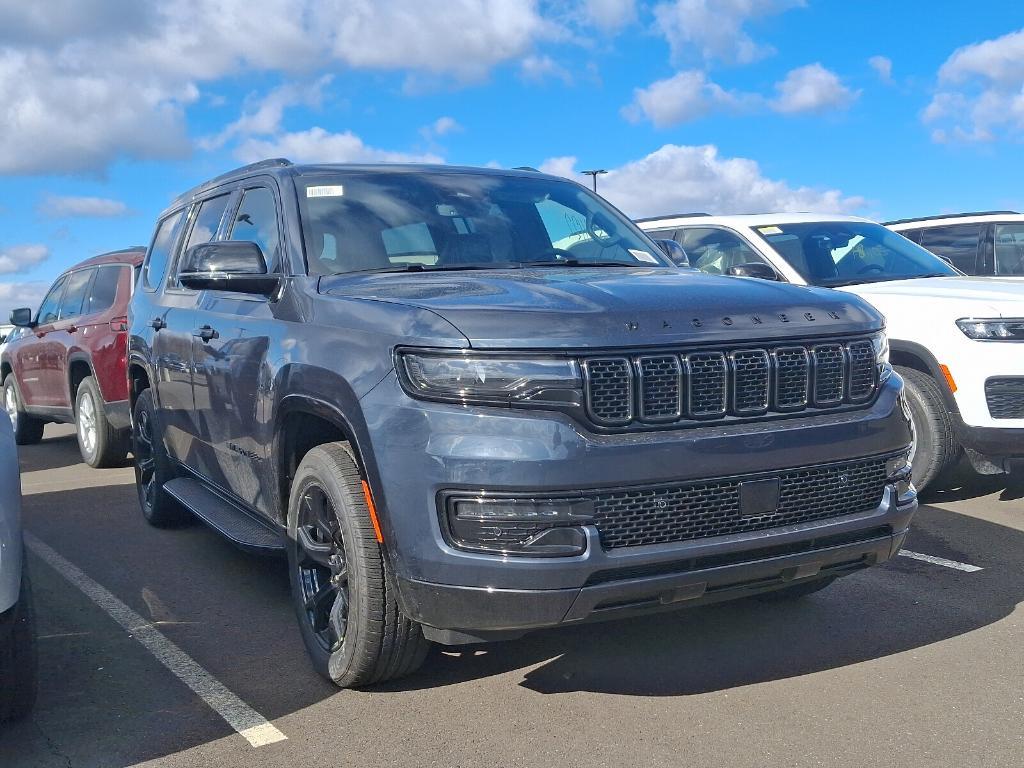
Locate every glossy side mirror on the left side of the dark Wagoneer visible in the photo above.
<box><xmin>178</xmin><ymin>240</ymin><xmax>281</xmax><ymax>296</ymax></box>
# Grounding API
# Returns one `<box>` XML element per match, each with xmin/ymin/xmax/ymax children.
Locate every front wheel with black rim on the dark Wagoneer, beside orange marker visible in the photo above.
<box><xmin>288</xmin><ymin>442</ymin><xmax>430</xmax><ymax>688</ymax></box>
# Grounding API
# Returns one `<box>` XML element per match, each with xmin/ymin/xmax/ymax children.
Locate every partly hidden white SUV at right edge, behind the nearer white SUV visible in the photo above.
<box><xmin>886</xmin><ymin>211</ymin><xmax>1024</xmax><ymax>278</ymax></box>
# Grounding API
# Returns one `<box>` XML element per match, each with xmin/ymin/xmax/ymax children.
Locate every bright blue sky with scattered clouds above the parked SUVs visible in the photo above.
<box><xmin>0</xmin><ymin>0</ymin><xmax>1024</xmax><ymax>316</ymax></box>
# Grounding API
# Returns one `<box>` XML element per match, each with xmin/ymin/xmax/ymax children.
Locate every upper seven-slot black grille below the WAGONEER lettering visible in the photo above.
<box><xmin>583</xmin><ymin>339</ymin><xmax>879</xmax><ymax>434</ymax></box>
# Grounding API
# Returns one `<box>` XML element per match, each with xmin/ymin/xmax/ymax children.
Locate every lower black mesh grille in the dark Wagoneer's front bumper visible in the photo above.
<box><xmin>594</xmin><ymin>457</ymin><xmax>886</xmax><ymax>549</ymax></box>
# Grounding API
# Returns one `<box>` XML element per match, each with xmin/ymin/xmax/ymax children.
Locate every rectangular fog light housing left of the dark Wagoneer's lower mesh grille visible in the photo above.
<box><xmin>445</xmin><ymin>496</ymin><xmax>594</xmax><ymax>557</ymax></box>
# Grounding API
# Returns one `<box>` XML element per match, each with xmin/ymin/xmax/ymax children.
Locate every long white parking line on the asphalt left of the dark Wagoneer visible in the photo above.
<box><xmin>25</xmin><ymin>532</ymin><xmax>288</xmax><ymax>746</ymax></box>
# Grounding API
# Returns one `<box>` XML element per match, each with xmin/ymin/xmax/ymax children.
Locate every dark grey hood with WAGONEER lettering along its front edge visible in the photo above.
<box><xmin>319</xmin><ymin>267</ymin><xmax>882</xmax><ymax>349</ymax></box>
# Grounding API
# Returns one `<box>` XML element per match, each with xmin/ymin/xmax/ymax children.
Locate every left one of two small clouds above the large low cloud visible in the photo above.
<box><xmin>623</xmin><ymin>70</ymin><xmax>756</xmax><ymax>128</ymax></box>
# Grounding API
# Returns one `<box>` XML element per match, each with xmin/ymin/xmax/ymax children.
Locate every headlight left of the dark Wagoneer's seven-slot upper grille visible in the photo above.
<box><xmin>397</xmin><ymin>350</ymin><xmax>583</xmax><ymax>406</ymax></box>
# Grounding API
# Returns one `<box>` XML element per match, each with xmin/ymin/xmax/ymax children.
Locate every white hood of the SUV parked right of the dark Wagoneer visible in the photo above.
<box><xmin>841</xmin><ymin>276</ymin><xmax>1024</xmax><ymax>318</ymax></box>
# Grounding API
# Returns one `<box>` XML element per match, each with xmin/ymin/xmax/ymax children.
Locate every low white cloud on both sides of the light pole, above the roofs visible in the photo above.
<box><xmin>541</xmin><ymin>144</ymin><xmax>866</xmax><ymax>217</ymax></box>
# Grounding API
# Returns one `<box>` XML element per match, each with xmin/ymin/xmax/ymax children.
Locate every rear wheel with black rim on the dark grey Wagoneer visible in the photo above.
<box><xmin>132</xmin><ymin>389</ymin><xmax>191</xmax><ymax>528</ymax></box>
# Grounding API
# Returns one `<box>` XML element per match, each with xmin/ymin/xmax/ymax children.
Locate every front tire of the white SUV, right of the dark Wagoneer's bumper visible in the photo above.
<box><xmin>896</xmin><ymin>368</ymin><xmax>961</xmax><ymax>492</ymax></box>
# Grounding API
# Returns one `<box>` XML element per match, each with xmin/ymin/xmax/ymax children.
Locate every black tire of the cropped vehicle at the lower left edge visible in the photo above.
<box><xmin>0</xmin><ymin>573</ymin><xmax>38</xmax><ymax>722</ymax></box>
